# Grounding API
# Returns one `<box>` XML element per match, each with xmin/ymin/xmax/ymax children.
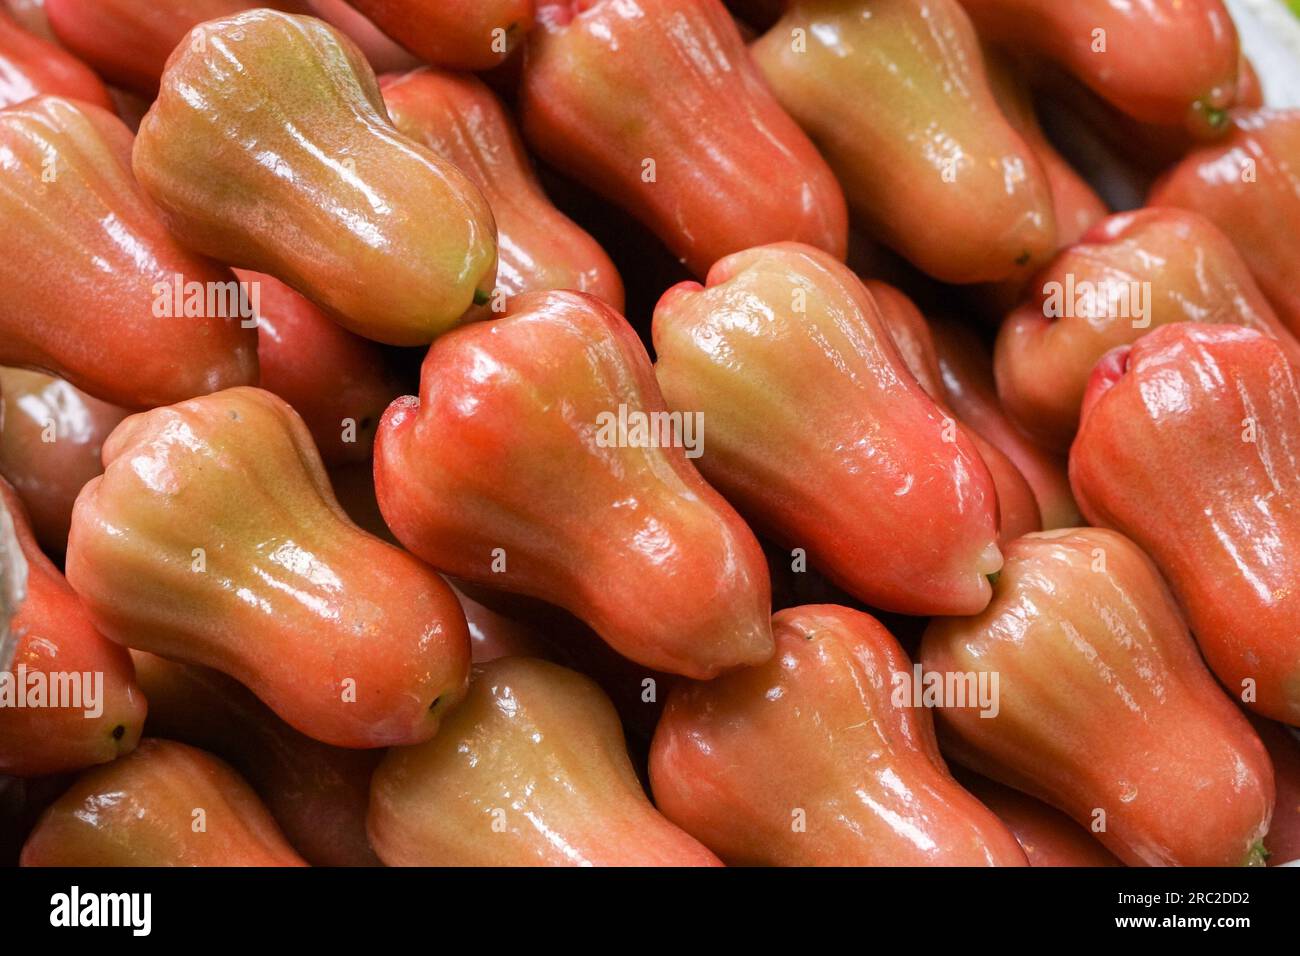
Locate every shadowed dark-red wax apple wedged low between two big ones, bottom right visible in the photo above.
<box><xmin>957</xmin><ymin>771</ymin><xmax>1123</xmax><ymax>866</ymax></box>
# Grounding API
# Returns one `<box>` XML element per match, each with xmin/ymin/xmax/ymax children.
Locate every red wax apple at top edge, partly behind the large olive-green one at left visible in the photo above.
<box><xmin>46</xmin><ymin>0</ymin><xmax>306</xmax><ymax>99</ymax></box>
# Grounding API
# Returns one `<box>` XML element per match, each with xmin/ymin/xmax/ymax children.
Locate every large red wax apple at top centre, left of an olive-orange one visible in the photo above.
<box><xmin>520</xmin><ymin>0</ymin><xmax>848</xmax><ymax>276</ymax></box>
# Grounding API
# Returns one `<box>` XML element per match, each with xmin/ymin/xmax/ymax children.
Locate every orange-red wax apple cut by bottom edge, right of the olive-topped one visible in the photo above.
<box><xmin>650</xmin><ymin>605</ymin><xmax>1026</xmax><ymax>866</ymax></box>
